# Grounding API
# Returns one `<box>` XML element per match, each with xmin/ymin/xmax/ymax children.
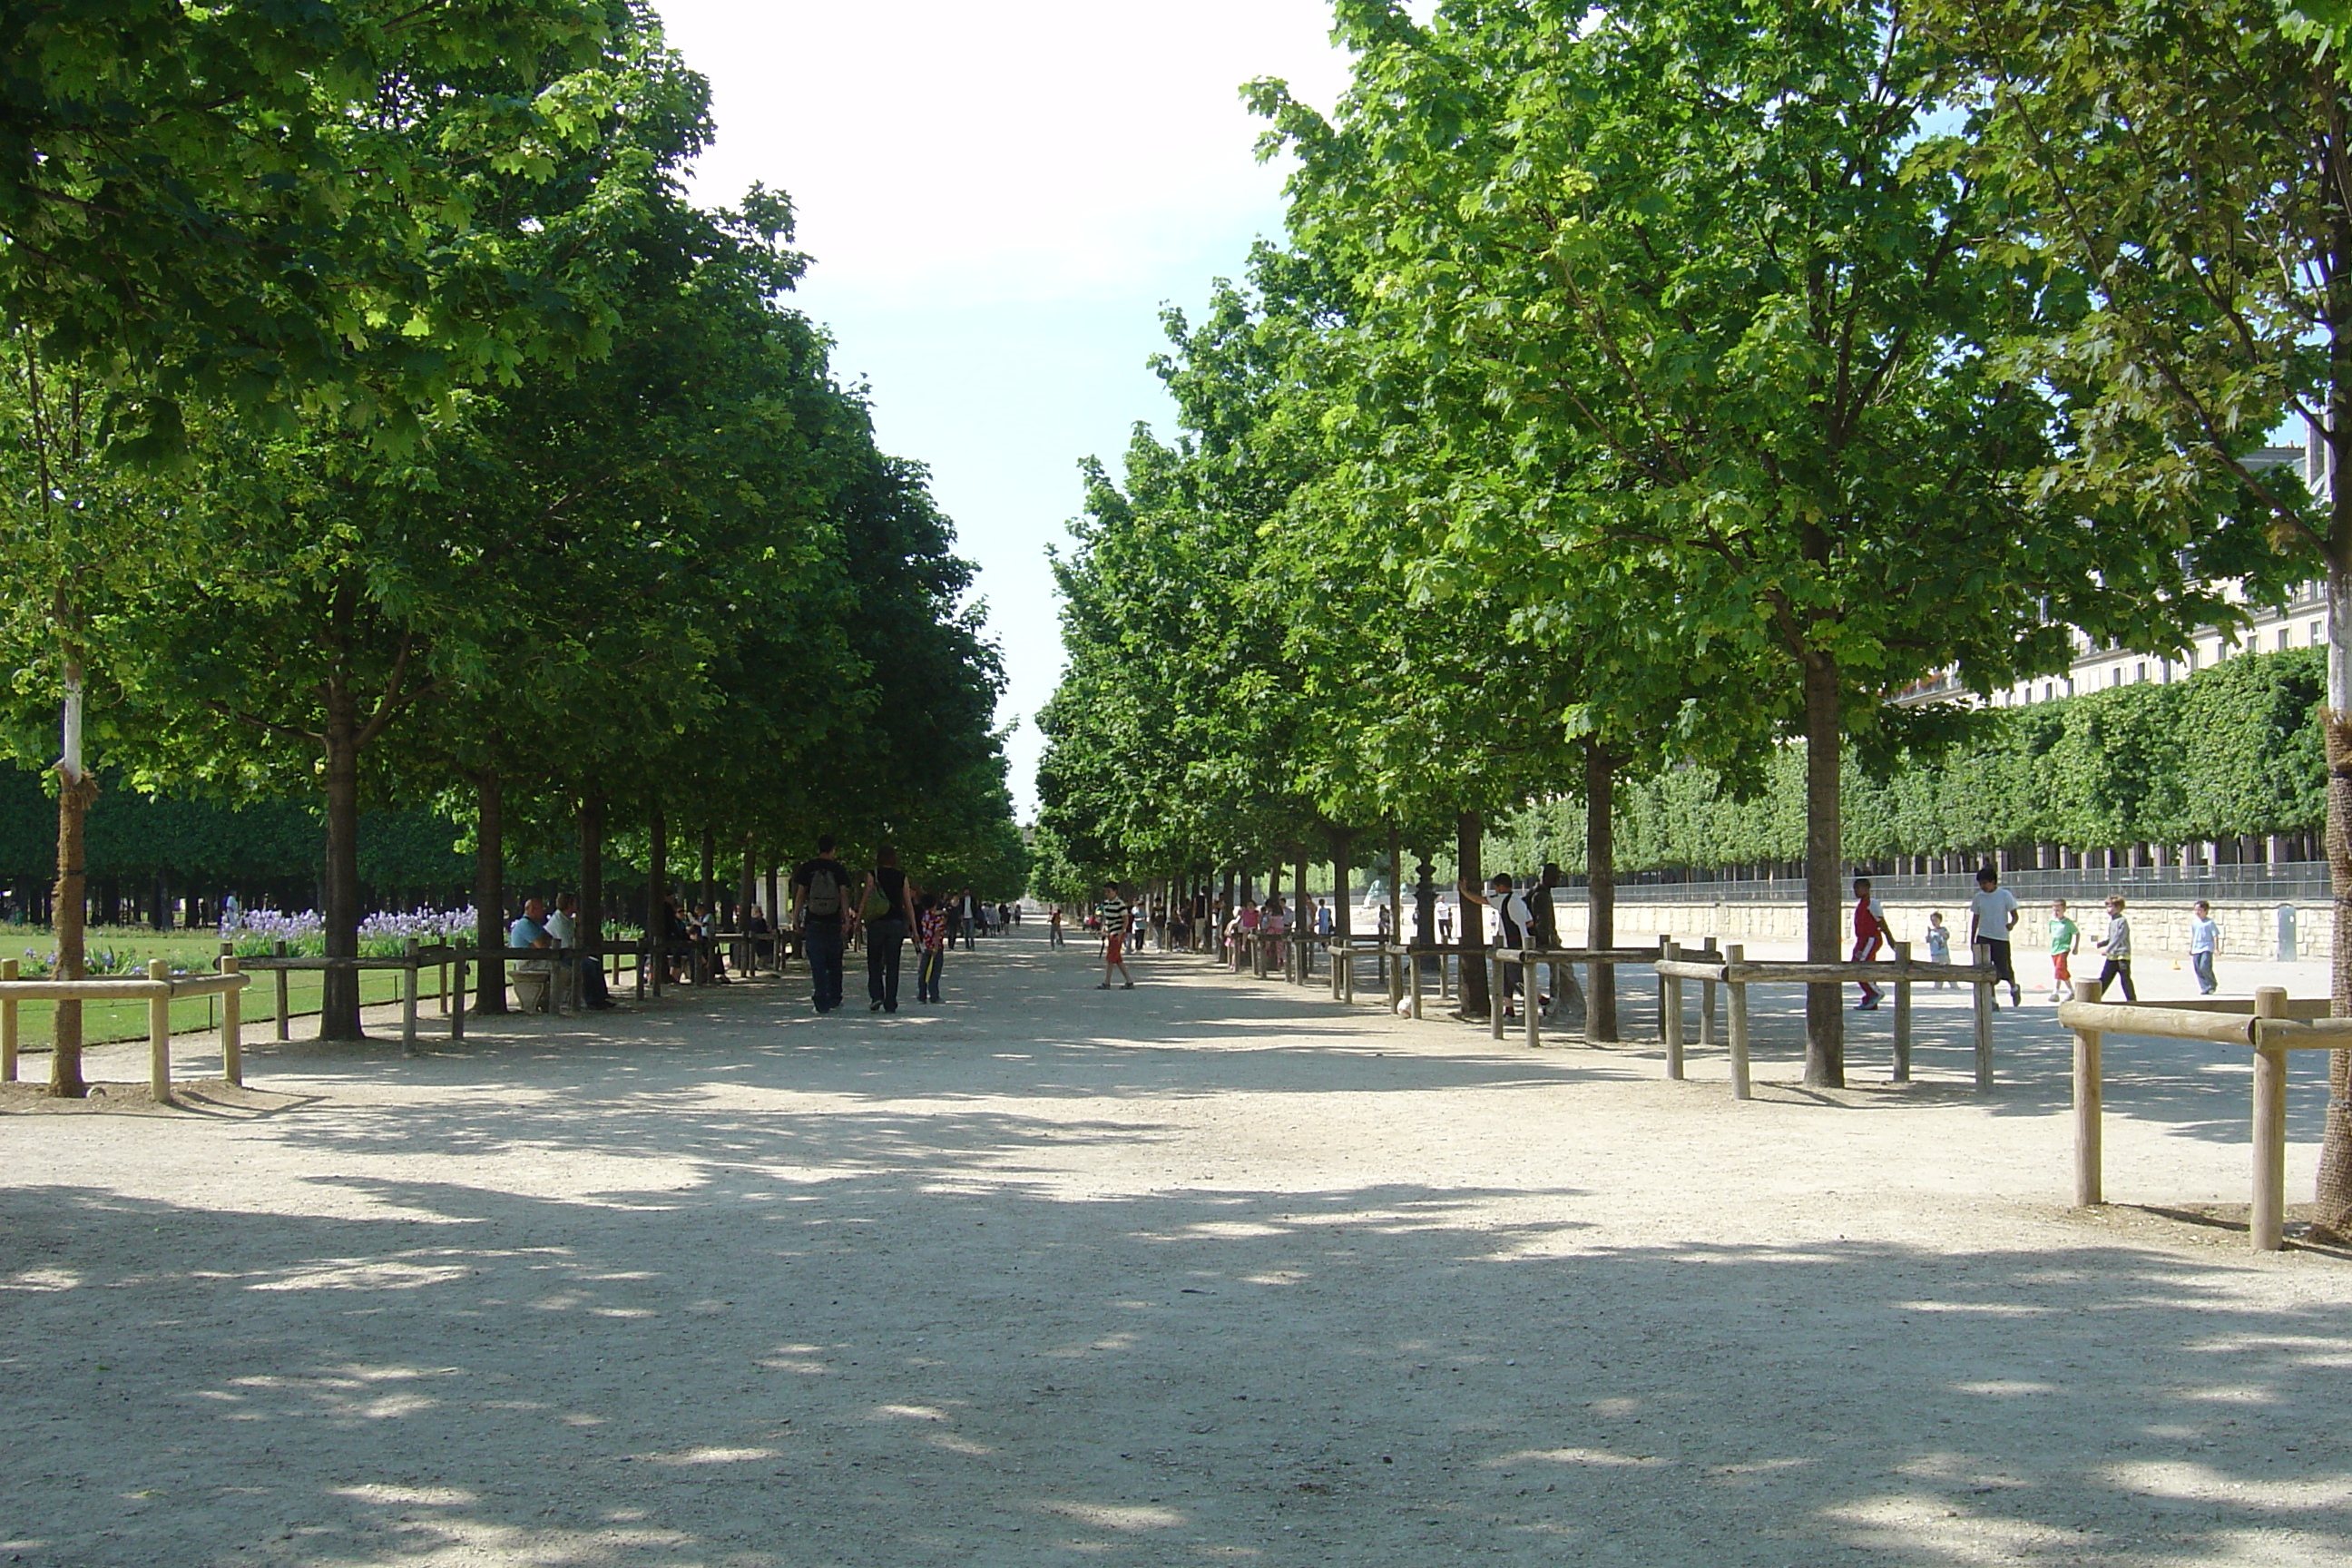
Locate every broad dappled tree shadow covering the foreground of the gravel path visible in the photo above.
<box><xmin>0</xmin><ymin>1098</ymin><xmax>2352</xmax><ymax>1568</ymax></box>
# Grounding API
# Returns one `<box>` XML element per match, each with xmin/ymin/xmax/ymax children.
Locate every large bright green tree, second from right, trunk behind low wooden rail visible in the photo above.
<box><xmin>1260</xmin><ymin>0</ymin><xmax>2268</xmax><ymax>1083</ymax></box>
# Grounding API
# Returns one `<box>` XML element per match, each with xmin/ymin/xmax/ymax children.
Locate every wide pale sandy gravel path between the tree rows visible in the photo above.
<box><xmin>0</xmin><ymin>934</ymin><xmax>2352</xmax><ymax>1568</ymax></box>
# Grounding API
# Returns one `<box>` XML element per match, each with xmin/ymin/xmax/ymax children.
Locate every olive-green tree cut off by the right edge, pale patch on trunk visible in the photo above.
<box><xmin>1919</xmin><ymin>0</ymin><xmax>2352</xmax><ymax>1234</ymax></box>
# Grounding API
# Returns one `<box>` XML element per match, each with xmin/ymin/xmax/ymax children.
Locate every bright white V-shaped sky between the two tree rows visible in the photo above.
<box><xmin>659</xmin><ymin>0</ymin><xmax>1346</xmax><ymax>818</ymax></box>
